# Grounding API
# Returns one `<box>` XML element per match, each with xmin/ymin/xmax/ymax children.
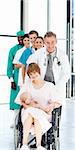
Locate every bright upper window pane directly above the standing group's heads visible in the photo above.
<box><xmin>28</xmin><ymin>0</ymin><xmax>47</xmax><ymax>36</ymax></box>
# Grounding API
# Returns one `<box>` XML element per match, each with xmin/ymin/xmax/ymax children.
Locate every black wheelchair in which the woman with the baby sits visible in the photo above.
<box><xmin>14</xmin><ymin>106</ymin><xmax>62</xmax><ymax>150</ymax></box>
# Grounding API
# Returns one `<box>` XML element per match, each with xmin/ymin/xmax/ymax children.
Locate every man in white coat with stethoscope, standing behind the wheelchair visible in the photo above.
<box><xmin>26</xmin><ymin>32</ymin><xmax>70</xmax><ymax>100</ymax></box>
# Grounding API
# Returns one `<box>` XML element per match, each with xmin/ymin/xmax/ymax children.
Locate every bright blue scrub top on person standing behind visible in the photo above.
<box><xmin>19</xmin><ymin>47</ymin><xmax>32</xmax><ymax>66</ymax></box>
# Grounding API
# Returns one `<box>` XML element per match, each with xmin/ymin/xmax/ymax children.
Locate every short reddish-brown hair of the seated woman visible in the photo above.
<box><xmin>27</xmin><ymin>63</ymin><xmax>40</xmax><ymax>78</ymax></box>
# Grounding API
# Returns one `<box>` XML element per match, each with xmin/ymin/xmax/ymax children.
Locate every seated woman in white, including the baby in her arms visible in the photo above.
<box><xmin>16</xmin><ymin>63</ymin><xmax>61</xmax><ymax>150</ymax></box>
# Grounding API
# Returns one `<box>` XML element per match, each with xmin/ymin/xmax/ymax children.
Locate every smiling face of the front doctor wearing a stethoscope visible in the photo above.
<box><xmin>44</xmin><ymin>36</ymin><xmax>57</xmax><ymax>53</ymax></box>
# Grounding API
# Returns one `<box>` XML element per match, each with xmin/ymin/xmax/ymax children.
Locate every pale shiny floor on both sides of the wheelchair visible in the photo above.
<box><xmin>0</xmin><ymin>99</ymin><xmax>75</xmax><ymax>150</ymax></box>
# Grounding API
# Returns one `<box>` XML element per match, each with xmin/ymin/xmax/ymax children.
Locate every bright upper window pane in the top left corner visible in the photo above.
<box><xmin>0</xmin><ymin>0</ymin><xmax>20</xmax><ymax>35</ymax></box>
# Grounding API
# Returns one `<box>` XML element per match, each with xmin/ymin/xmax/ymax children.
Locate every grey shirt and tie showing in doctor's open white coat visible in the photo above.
<box><xmin>44</xmin><ymin>54</ymin><xmax>55</xmax><ymax>84</ymax></box>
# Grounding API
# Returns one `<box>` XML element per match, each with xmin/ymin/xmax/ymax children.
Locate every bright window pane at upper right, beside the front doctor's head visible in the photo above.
<box><xmin>49</xmin><ymin>0</ymin><xmax>67</xmax><ymax>52</ymax></box>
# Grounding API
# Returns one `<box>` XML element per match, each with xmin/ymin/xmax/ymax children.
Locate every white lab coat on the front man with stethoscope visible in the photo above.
<box><xmin>27</xmin><ymin>47</ymin><xmax>70</xmax><ymax>102</ymax></box>
